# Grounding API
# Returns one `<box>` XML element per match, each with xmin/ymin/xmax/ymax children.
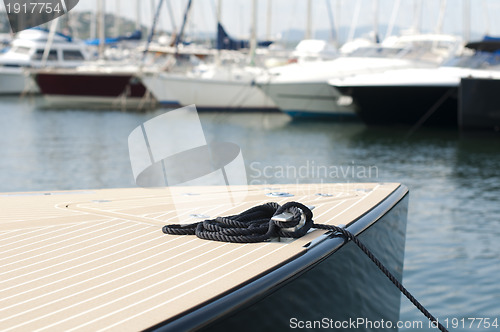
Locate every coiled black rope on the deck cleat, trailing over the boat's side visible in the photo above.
<box><xmin>163</xmin><ymin>202</ymin><xmax>448</xmax><ymax>332</ymax></box>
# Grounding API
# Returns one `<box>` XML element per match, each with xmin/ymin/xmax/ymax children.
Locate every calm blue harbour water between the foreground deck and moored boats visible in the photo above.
<box><xmin>0</xmin><ymin>97</ymin><xmax>500</xmax><ymax>330</ymax></box>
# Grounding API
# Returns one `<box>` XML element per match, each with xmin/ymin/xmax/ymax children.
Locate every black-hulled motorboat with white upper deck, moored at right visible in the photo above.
<box><xmin>329</xmin><ymin>42</ymin><xmax>500</xmax><ymax>126</ymax></box>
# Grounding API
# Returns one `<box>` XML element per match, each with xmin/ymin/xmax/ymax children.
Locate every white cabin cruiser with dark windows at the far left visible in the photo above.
<box><xmin>0</xmin><ymin>28</ymin><xmax>89</xmax><ymax>94</ymax></box>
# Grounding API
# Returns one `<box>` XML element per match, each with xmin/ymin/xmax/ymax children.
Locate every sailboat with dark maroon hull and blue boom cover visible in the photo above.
<box><xmin>31</xmin><ymin>1</ymin><xmax>156</xmax><ymax>109</ymax></box>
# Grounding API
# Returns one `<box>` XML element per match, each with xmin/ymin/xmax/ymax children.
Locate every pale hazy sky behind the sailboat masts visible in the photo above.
<box><xmin>48</xmin><ymin>0</ymin><xmax>500</xmax><ymax>37</ymax></box>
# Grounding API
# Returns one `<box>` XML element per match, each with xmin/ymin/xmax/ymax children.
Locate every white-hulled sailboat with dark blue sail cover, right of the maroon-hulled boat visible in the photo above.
<box><xmin>141</xmin><ymin>0</ymin><xmax>276</xmax><ymax>111</ymax></box>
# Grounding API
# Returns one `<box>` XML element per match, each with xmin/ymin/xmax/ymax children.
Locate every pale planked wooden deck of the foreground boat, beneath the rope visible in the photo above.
<box><xmin>0</xmin><ymin>184</ymin><xmax>399</xmax><ymax>331</ymax></box>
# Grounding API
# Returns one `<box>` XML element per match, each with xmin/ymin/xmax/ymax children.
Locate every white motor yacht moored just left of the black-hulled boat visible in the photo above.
<box><xmin>257</xmin><ymin>34</ymin><xmax>462</xmax><ymax>118</ymax></box>
